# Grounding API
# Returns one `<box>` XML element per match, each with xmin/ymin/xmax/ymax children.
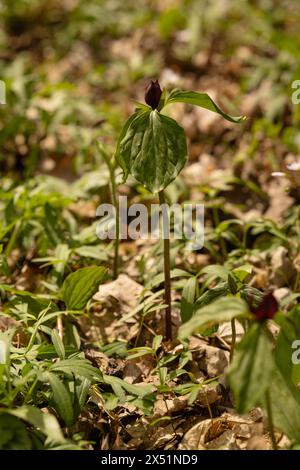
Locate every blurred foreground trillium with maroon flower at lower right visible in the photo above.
<box><xmin>178</xmin><ymin>280</ymin><xmax>300</xmax><ymax>449</ymax></box>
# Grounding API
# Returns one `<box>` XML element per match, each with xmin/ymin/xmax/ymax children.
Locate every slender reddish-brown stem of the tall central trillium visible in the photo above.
<box><xmin>158</xmin><ymin>190</ymin><xmax>172</xmax><ymax>340</ymax></box>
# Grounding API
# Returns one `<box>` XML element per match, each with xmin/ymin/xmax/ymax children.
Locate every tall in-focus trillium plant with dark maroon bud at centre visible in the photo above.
<box><xmin>115</xmin><ymin>80</ymin><xmax>244</xmax><ymax>339</ymax></box>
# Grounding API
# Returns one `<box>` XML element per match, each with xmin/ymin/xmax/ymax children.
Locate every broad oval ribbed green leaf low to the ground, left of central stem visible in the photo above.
<box><xmin>62</xmin><ymin>266</ymin><xmax>107</xmax><ymax>310</ymax></box>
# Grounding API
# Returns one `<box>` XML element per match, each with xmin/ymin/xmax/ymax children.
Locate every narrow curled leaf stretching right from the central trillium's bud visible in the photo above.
<box><xmin>165</xmin><ymin>89</ymin><xmax>246</xmax><ymax>123</ymax></box>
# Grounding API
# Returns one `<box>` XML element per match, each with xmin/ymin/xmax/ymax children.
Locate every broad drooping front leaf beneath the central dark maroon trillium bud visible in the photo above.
<box><xmin>116</xmin><ymin>110</ymin><xmax>187</xmax><ymax>193</ymax></box>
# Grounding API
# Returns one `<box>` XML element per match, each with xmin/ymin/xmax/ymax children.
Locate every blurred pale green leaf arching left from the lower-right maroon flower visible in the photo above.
<box><xmin>178</xmin><ymin>297</ymin><xmax>248</xmax><ymax>340</ymax></box>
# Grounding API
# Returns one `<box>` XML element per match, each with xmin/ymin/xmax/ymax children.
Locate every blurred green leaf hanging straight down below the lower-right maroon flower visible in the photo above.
<box><xmin>227</xmin><ymin>323</ymin><xmax>274</xmax><ymax>413</ymax></box>
